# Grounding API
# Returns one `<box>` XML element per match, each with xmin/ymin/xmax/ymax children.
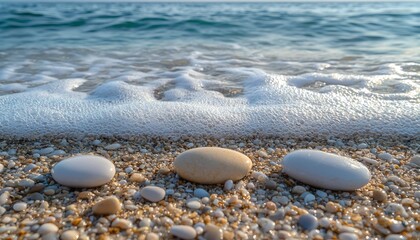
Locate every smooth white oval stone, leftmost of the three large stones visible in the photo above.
<box><xmin>51</xmin><ymin>155</ymin><xmax>115</xmax><ymax>188</ymax></box>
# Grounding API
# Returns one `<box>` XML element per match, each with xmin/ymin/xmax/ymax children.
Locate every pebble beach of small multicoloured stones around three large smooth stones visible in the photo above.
<box><xmin>0</xmin><ymin>136</ymin><xmax>420</xmax><ymax>240</ymax></box>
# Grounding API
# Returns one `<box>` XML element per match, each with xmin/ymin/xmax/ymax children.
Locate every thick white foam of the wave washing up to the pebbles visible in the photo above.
<box><xmin>0</xmin><ymin>68</ymin><xmax>420</xmax><ymax>137</ymax></box>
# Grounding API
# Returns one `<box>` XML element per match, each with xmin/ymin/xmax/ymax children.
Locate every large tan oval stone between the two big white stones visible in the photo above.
<box><xmin>174</xmin><ymin>147</ymin><xmax>252</xmax><ymax>184</ymax></box>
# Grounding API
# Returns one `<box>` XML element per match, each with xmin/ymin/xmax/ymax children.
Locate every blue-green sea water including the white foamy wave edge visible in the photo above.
<box><xmin>0</xmin><ymin>3</ymin><xmax>420</xmax><ymax>138</ymax></box>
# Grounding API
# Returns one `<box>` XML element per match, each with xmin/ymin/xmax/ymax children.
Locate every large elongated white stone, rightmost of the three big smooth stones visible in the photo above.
<box><xmin>283</xmin><ymin>150</ymin><xmax>371</xmax><ymax>191</ymax></box>
